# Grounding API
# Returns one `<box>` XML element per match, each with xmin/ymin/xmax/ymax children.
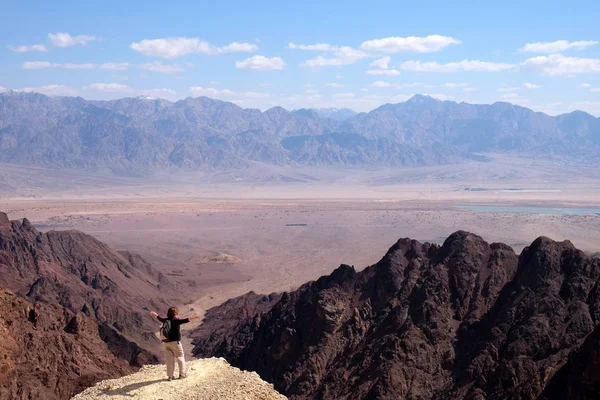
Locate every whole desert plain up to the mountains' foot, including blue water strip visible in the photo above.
<box><xmin>0</xmin><ymin>159</ymin><xmax>600</xmax><ymax>334</ymax></box>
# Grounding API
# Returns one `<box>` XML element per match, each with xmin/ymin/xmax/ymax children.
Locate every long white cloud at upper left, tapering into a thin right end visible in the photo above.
<box><xmin>129</xmin><ymin>37</ymin><xmax>258</xmax><ymax>58</ymax></box>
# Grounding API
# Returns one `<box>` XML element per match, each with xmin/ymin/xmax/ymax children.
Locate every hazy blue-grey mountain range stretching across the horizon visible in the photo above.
<box><xmin>0</xmin><ymin>92</ymin><xmax>600</xmax><ymax>170</ymax></box>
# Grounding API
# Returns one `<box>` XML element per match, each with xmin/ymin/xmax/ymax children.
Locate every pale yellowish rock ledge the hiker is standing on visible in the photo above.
<box><xmin>72</xmin><ymin>358</ymin><xmax>285</xmax><ymax>400</ymax></box>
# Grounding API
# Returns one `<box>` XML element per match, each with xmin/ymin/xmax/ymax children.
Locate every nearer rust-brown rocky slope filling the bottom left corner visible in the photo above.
<box><xmin>0</xmin><ymin>289</ymin><xmax>134</xmax><ymax>400</ymax></box>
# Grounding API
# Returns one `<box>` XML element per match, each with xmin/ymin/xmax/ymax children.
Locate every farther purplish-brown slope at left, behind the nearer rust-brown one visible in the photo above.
<box><xmin>0</xmin><ymin>212</ymin><xmax>183</xmax><ymax>366</ymax></box>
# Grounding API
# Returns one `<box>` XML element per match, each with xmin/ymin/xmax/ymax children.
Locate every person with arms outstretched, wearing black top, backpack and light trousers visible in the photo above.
<box><xmin>150</xmin><ymin>307</ymin><xmax>200</xmax><ymax>381</ymax></box>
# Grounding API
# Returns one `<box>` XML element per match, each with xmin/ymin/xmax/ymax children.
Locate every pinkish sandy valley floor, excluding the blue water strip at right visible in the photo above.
<box><xmin>0</xmin><ymin>177</ymin><xmax>600</xmax><ymax>332</ymax></box>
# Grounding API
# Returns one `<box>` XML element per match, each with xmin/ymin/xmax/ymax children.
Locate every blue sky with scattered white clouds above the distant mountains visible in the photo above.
<box><xmin>0</xmin><ymin>0</ymin><xmax>600</xmax><ymax>116</ymax></box>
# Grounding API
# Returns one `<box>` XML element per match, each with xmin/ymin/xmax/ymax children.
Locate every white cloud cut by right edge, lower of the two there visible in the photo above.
<box><xmin>523</xmin><ymin>54</ymin><xmax>600</xmax><ymax>76</ymax></box>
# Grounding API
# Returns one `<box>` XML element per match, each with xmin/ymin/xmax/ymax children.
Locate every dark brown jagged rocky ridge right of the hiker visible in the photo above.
<box><xmin>195</xmin><ymin>232</ymin><xmax>600</xmax><ymax>399</ymax></box>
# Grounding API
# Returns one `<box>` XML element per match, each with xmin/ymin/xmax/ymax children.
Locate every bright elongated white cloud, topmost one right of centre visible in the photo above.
<box><xmin>359</xmin><ymin>35</ymin><xmax>461</xmax><ymax>53</ymax></box>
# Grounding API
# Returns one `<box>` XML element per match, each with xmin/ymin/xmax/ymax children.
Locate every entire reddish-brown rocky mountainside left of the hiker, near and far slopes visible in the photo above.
<box><xmin>0</xmin><ymin>212</ymin><xmax>190</xmax><ymax>399</ymax></box>
